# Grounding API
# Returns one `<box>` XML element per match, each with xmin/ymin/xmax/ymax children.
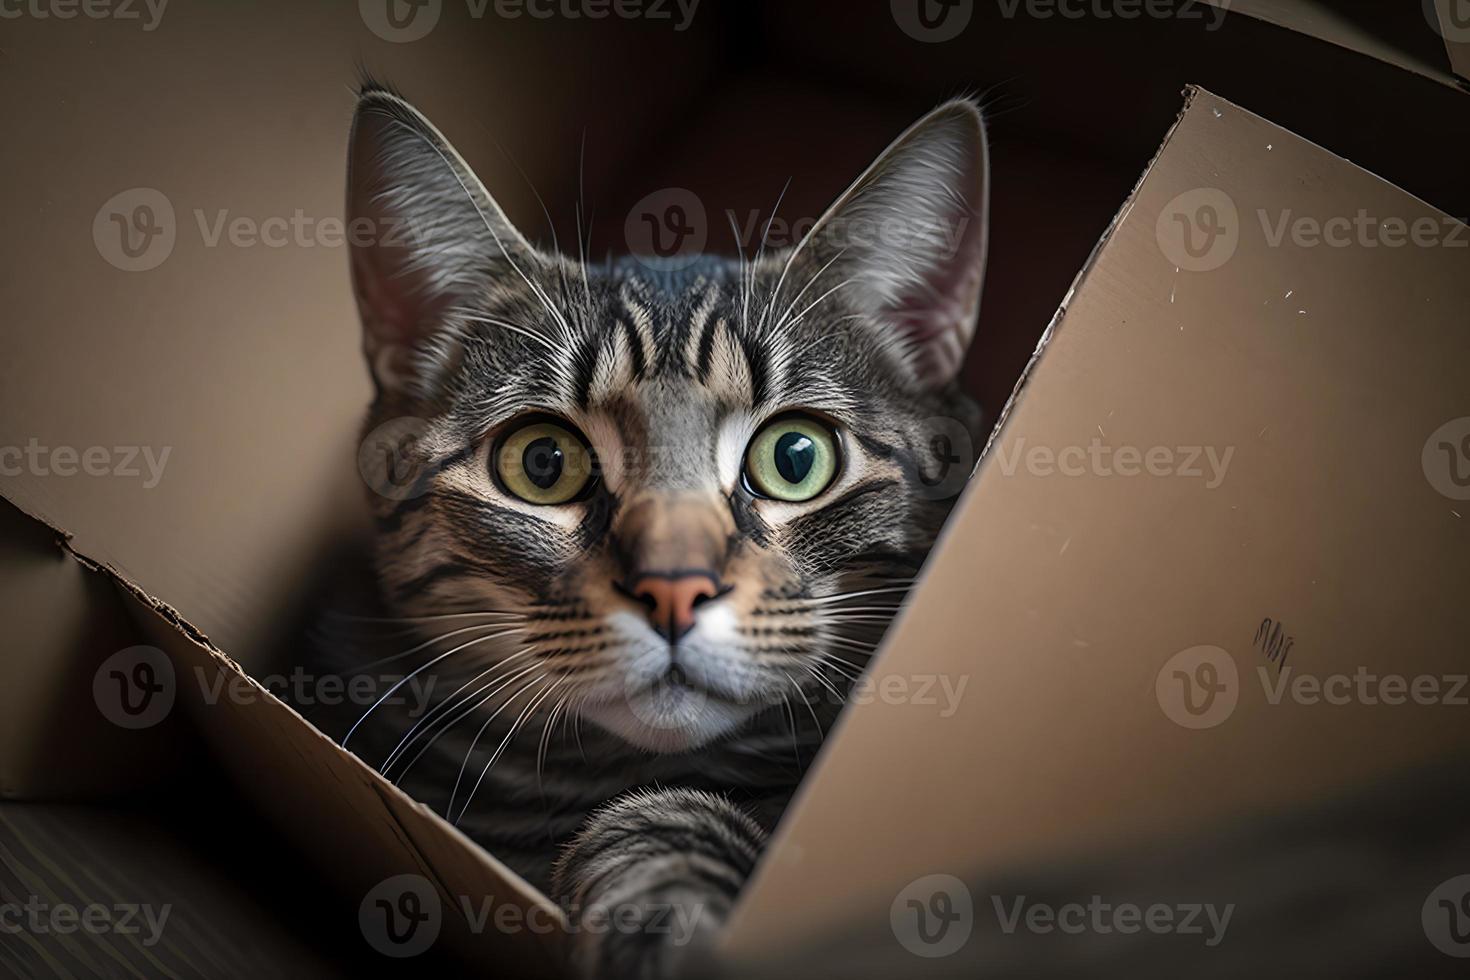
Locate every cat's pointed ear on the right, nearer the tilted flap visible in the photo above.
<box><xmin>800</xmin><ymin>100</ymin><xmax>989</xmax><ymax>386</ymax></box>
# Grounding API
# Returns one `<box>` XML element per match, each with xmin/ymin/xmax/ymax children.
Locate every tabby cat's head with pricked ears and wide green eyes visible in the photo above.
<box><xmin>348</xmin><ymin>90</ymin><xmax>988</xmax><ymax>751</ymax></box>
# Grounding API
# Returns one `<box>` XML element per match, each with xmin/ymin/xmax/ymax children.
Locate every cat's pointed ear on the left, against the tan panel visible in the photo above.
<box><xmin>347</xmin><ymin>87</ymin><xmax>539</xmax><ymax>394</ymax></box>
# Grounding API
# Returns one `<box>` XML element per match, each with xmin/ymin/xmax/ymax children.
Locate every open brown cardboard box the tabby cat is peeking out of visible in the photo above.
<box><xmin>0</xmin><ymin>0</ymin><xmax>1470</xmax><ymax>976</ymax></box>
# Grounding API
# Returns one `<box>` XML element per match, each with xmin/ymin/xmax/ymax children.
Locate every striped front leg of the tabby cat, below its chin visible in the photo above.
<box><xmin>551</xmin><ymin>789</ymin><xmax>766</xmax><ymax>980</ymax></box>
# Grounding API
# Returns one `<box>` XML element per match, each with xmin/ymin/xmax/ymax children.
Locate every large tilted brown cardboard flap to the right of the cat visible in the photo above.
<box><xmin>726</xmin><ymin>84</ymin><xmax>1470</xmax><ymax>958</ymax></box>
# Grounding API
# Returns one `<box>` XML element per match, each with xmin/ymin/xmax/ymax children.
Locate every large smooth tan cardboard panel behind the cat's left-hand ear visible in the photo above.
<box><xmin>0</xmin><ymin>0</ymin><xmax>707</xmax><ymax>681</ymax></box>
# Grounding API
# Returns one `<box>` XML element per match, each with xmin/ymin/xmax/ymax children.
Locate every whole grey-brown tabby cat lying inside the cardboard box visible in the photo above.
<box><xmin>341</xmin><ymin>85</ymin><xmax>988</xmax><ymax>977</ymax></box>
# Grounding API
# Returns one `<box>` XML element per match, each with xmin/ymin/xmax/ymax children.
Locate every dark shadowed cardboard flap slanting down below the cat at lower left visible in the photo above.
<box><xmin>106</xmin><ymin>564</ymin><xmax>564</xmax><ymax>977</ymax></box>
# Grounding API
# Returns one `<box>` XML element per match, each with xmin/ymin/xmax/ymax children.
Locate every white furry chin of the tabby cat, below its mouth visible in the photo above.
<box><xmin>582</xmin><ymin>686</ymin><xmax>760</xmax><ymax>752</ymax></box>
